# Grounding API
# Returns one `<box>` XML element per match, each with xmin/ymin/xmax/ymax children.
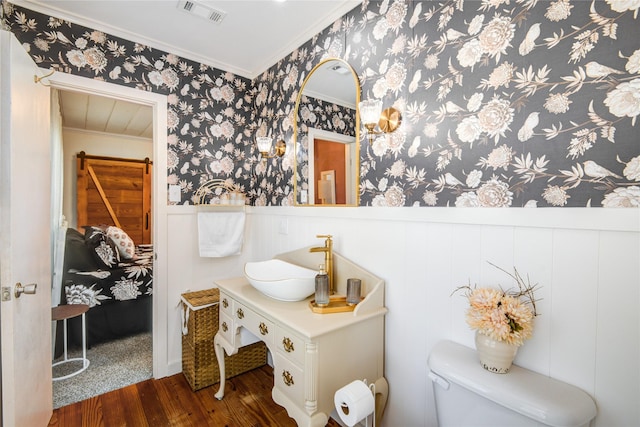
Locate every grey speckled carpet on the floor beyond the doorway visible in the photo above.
<box><xmin>53</xmin><ymin>333</ymin><xmax>153</xmax><ymax>409</ymax></box>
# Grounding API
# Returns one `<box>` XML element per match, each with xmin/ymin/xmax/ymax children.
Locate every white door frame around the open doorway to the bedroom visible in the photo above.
<box><xmin>41</xmin><ymin>69</ymin><xmax>169</xmax><ymax>378</ymax></box>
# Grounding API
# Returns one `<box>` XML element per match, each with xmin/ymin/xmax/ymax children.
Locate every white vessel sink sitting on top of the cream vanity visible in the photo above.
<box><xmin>244</xmin><ymin>259</ymin><xmax>317</xmax><ymax>301</ymax></box>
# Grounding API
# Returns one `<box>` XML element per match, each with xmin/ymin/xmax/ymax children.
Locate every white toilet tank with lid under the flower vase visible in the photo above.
<box><xmin>428</xmin><ymin>341</ymin><xmax>597</xmax><ymax>427</ymax></box>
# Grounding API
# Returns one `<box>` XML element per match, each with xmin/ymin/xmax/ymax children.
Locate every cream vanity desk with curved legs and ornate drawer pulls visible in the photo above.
<box><xmin>214</xmin><ymin>247</ymin><xmax>387</xmax><ymax>427</ymax></box>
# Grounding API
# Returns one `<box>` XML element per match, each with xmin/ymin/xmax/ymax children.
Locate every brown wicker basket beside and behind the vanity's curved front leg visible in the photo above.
<box><xmin>182</xmin><ymin>289</ymin><xmax>267</xmax><ymax>391</ymax></box>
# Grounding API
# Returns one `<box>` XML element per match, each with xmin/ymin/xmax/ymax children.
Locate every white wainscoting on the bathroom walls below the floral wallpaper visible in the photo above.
<box><xmin>167</xmin><ymin>206</ymin><xmax>640</xmax><ymax>427</ymax></box>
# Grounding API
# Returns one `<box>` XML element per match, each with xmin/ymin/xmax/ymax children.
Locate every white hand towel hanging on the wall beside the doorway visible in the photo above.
<box><xmin>198</xmin><ymin>211</ymin><xmax>245</xmax><ymax>257</ymax></box>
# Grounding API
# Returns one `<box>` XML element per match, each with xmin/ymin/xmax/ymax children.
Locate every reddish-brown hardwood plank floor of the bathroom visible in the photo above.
<box><xmin>49</xmin><ymin>365</ymin><xmax>340</xmax><ymax>427</ymax></box>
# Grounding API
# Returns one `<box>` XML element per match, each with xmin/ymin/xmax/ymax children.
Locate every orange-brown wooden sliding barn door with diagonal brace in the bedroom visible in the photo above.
<box><xmin>76</xmin><ymin>153</ymin><xmax>151</xmax><ymax>245</ymax></box>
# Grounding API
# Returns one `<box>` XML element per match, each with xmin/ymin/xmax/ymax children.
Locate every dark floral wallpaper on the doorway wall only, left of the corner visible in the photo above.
<box><xmin>2</xmin><ymin>2</ymin><xmax>264</xmax><ymax>204</ymax></box>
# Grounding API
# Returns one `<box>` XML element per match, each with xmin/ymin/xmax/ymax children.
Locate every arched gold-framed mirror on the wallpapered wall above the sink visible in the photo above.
<box><xmin>293</xmin><ymin>58</ymin><xmax>360</xmax><ymax>206</ymax></box>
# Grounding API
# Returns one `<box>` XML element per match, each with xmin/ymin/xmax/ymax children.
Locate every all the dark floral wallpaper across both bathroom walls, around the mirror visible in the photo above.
<box><xmin>3</xmin><ymin>0</ymin><xmax>640</xmax><ymax>207</ymax></box>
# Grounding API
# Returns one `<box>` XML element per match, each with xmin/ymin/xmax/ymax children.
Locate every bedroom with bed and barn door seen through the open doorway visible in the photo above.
<box><xmin>53</xmin><ymin>90</ymin><xmax>154</xmax><ymax>407</ymax></box>
